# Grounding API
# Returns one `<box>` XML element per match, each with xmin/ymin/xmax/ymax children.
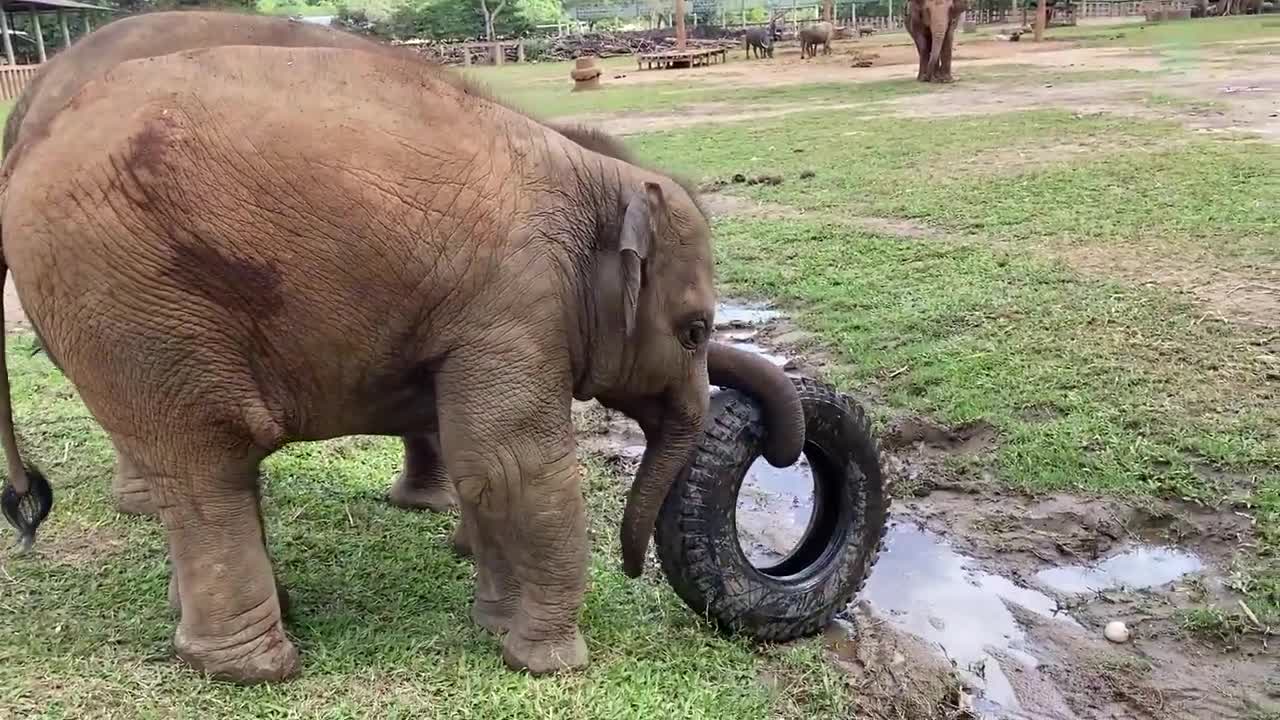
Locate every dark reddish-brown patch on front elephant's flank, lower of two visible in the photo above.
<box><xmin>165</xmin><ymin>237</ymin><xmax>284</xmax><ymax>318</ymax></box>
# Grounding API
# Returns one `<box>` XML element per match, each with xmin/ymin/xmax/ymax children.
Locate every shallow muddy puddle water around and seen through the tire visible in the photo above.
<box><xmin>586</xmin><ymin>297</ymin><xmax>1259</xmax><ymax>719</ymax></box>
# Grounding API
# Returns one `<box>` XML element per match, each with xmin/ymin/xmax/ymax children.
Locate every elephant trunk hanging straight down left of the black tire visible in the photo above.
<box><xmin>622</xmin><ymin>386</ymin><xmax>708</xmax><ymax>578</ymax></box>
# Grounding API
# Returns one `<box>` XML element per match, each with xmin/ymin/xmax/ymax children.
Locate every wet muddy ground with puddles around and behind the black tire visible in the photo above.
<box><xmin>588</xmin><ymin>295</ymin><xmax>1280</xmax><ymax>719</ymax></box>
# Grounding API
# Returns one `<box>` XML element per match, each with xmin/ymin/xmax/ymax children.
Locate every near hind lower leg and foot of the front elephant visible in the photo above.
<box><xmin>147</xmin><ymin>443</ymin><xmax>298</xmax><ymax>683</ymax></box>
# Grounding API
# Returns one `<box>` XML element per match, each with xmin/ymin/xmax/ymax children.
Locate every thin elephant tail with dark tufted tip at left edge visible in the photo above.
<box><xmin>0</xmin><ymin>177</ymin><xmax>54</xmax><ymax>551</ymax></box>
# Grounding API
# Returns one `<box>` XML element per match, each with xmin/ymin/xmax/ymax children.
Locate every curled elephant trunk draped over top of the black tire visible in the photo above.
<box><xmin>707</xmin><ymin>342</ymin><xmax>804</xmax><ymax>468</ymax></box>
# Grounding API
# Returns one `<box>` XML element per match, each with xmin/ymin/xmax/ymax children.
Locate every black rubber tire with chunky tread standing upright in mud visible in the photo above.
<box><xmin>655</xmin><ymin>378</ymin><xmax>890</xmax><ymax>642</ymax></box>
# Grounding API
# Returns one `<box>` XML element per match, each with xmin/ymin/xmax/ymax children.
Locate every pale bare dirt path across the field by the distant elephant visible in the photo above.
<box><xmin>572</xmin><ymin>40</ymin><xmax>1280</xmax><ymax>142</ymax></box>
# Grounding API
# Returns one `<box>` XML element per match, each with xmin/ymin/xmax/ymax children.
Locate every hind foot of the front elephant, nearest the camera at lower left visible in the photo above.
<box><xmin>173</xmin><ymin>612</ymin><xmax>300</xmax><ymax>685</ymax></box>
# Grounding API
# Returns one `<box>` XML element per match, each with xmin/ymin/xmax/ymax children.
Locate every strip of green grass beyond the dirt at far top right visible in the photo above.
<box><xmin>1046</xmin><ymin>15</ymin><xmax>1280</xmax><ymax>47</ymax></box>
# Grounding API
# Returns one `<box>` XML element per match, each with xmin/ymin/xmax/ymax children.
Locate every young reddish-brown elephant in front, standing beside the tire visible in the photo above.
<box><xmin>0</xmin><ymin>46</ymin><xmax>804</xmax><ymax>682</ymax></box>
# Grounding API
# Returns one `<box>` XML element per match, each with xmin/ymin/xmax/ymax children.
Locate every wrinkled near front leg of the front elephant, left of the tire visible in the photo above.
<box><xmin>438</xmin><ymin>363</ymin><xmax>588</xmax><ymax>674</ymax></box>
